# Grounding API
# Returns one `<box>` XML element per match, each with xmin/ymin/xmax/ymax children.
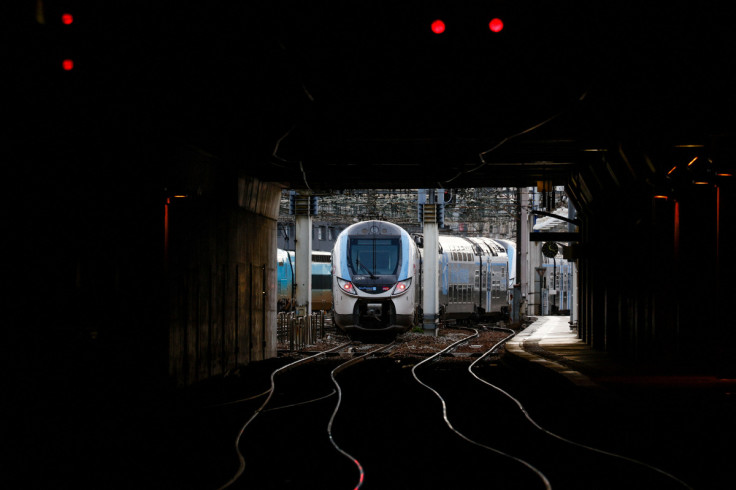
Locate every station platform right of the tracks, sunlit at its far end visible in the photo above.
<box><xmin>502</xmin><ymin>316</ymin><xmax>736</xmax><ymax>490</ymax></box>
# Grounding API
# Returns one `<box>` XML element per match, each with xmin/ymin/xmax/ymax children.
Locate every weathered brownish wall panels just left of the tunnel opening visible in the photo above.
<box><xmin>166</xmin><ymin>177</ymin><xmax>281</xmax><ymax>385</ymax></box>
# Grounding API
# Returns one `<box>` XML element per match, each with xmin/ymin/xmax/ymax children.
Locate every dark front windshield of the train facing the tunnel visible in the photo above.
<box><xmin>348</xmin><ymin>238</ymin><xmax>401</xmax><ymax>276</ymax></box>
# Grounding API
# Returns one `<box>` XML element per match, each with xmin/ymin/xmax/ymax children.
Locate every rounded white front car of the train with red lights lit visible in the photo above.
<box><xmin>332</xmin><ymin>220</ymin><xmax>421</xmax><ymax>332</ymax></box>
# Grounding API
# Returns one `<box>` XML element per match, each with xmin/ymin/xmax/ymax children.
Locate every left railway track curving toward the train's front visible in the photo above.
<box><xmin>220</xmin><ymin>342</ymin><xmax>400</xmax><ymax>489</ymax></box>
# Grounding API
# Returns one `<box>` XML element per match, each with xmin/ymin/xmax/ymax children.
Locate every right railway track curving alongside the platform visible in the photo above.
<box><xmin>414</xmin><ymin>331</ymin><xmax>691</xmax><ymax>489</ymax></box>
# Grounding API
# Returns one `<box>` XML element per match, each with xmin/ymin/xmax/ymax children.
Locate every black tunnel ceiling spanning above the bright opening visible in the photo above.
<box><xmin>21</xmin><ymin>0</ymin><xmax>736</xmax><ymax>193</ymax></box>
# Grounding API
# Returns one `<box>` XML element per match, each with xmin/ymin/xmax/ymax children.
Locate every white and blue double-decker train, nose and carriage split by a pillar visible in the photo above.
<box><xmin>332</xmin><ymin>221</ymin><xmax>512</xmax><ymax>332</ymax></box>
